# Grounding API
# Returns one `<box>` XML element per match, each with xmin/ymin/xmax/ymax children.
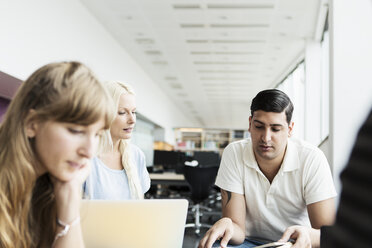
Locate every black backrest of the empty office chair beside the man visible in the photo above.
<box><xmin>184</xmin><ymin>166</ymin><xmax>218</xmax><ymax>203</ymax></box>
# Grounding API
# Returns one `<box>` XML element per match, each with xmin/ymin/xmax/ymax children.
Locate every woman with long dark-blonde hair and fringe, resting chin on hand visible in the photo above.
<box><xmin>0</xmin><ymin>62</ymin><xmax>113</xmax><ymax>248</ymax></box>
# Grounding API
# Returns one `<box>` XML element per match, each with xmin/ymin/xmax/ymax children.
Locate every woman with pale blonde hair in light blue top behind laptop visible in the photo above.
<box><xmin>84</xmin><ymin>82</ymin><xmax>150</xmax><ymax>200</ymax></box>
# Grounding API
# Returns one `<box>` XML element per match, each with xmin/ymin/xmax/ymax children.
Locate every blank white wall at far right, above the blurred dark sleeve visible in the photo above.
<box><xmin>329</xmin><ymin>0</ymin><xmax>372</xmax><ymax>194</ymax></box>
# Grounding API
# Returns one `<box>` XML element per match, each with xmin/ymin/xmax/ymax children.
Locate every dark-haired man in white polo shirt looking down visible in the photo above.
<box><xmin>199</xmin><ymin>89</ymin><xmax>336</xmax><ymax>248</ymax></box>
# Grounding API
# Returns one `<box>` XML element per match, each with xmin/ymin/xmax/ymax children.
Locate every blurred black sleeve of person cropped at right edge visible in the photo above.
<box><xmin>321</xmin><ymin>111</ymin><xmax>372</xmax><ymax>248</ymax></box>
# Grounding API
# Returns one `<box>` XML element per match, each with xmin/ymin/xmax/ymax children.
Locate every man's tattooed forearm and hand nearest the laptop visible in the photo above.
<box><xmin>199</xmin><ymin>189</ymin><xmax>246</xmax><ymax>248</ymax></box>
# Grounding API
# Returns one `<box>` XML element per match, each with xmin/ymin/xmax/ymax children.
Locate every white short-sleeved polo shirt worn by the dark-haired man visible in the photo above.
<box><xmin>216</xmin><ymin>139</ymin><xmax>337</xmax><ymax>240</ymax></box>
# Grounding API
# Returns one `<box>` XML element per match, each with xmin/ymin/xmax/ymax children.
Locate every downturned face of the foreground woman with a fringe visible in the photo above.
<box><xmin>27</xmin><ymin>119</ymin><xmax>104</xmax><ymax>181</ymax></box>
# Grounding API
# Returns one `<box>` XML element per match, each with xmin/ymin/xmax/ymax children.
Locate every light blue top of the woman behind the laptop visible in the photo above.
<box><xmin>83</xmin><ymin>144</ymin><xmax>150</xmax><ymax>200</ymax></box>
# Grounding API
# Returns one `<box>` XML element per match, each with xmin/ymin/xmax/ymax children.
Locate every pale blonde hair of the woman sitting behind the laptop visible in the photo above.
<box><xmin>99</xmin><ymin>81</ymin><xmax>143</xmax><ymax>199</ymax></box>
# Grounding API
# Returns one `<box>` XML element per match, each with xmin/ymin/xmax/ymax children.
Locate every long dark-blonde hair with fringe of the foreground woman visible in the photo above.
<box><xmin>0</xmin><ymin>62</ymin><xmax>113</xmax><ymax>248</ymax></box>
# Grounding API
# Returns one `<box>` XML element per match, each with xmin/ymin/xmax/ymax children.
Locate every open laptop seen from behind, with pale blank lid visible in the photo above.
<box><xmin>80</xmin><ymin>199</ymin><xmax>188</xmax><ymax>248</ymax></box>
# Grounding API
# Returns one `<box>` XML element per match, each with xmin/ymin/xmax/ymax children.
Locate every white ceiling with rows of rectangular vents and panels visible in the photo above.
<box><xmin>81</xmin><ymin>0</ymin><xmax>320</xmax><ymax>128</ymax></box>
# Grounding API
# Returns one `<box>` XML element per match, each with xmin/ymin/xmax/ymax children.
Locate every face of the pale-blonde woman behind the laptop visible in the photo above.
<box><xmin>110</xmin><ymin>93</ymin><xmax>136</xmax><ymax>140</ymax></box>
